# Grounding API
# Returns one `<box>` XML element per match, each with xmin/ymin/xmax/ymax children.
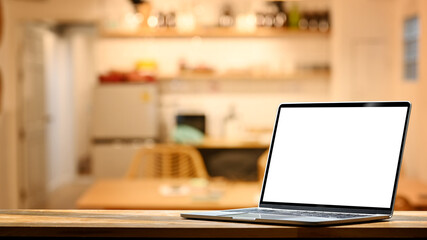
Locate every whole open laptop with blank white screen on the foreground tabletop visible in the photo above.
<box><xmin>181</xmin><ymin>101</ymin><xmax>411</xmax><ymax>226</ymax></box>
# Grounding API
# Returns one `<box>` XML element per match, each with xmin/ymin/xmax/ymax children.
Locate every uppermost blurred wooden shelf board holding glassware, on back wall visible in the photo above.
<box><xmin>101</xmin><ymin>27</ymin><xmax>330</xmax><ymax>38</ymax></box>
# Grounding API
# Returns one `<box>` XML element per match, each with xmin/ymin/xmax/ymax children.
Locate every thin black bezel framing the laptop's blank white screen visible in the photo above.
<box><xmin>259</xmin><ymin>101</ymin><xmax>411</xmax><ymax>215</ymax></box>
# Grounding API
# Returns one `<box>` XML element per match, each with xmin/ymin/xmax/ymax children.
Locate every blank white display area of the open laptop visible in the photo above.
<box><xmin>263</xmin><ymin>107</ymin><xmax>407</xmax><ymax>208</ymax></box>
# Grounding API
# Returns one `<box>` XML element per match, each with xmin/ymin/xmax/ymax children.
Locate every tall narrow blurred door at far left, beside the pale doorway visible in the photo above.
<box><xmin>18</xmin><ymin>25</ymin><xmax>47</xmax><ymax>208</ymax></box>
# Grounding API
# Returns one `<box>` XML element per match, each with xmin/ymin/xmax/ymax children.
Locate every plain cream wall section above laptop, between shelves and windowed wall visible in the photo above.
<box><xmin>331</xmin><ymin>0</ymin><xmax>395</xmax><ymax>101</ymax></box>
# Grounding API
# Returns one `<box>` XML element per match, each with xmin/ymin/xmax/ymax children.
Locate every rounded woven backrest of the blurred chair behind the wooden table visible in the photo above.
<box><xmin>127</xmin><ymin>144</ymin><xmax>209</xmax><ymax>178</ymax></box>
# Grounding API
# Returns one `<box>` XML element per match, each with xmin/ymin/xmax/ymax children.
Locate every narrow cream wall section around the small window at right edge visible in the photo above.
<box><xmin>392</xmin><ymin>0</ymin><xmax>427</xmax><ymax>182</ymax></box>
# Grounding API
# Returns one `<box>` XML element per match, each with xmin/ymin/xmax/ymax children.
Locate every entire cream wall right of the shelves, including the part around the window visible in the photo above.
<box><xmin>332</xmin><ymin>0</ymin><xmax>427</xmax><ymax>181</ymax></box>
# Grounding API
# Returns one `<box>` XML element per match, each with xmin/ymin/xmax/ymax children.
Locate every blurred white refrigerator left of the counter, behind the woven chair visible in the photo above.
<box><xmin>91</xmin><ymin>83</ymin><xmax>159</xmax><ymax>178</ymax></box>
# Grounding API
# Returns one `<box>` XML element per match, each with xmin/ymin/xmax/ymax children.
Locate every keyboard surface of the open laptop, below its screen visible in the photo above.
<box><xmin>227</xmin><ymin>208</ymin><xmax>369</xmax><ymax>218</ymax></box>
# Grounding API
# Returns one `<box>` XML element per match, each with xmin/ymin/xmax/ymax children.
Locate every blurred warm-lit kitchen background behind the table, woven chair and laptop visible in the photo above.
<box><xmin>0</xmin><ymin>0</ymin><xmax>427</xmax><ymax>208</ymax></box>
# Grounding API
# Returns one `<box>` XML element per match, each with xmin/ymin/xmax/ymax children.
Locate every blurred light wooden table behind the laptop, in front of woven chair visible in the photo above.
<box><xmin>77</xmin><ymin>179</ymin><xmax>261</xmax><ymax>210</ymax></box>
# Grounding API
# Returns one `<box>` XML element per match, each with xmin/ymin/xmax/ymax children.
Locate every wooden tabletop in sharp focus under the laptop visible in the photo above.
<box><xmin>0</xmin><ymin>210</ymin><xmax>427</xmax><ymax>238</ymax></box>
